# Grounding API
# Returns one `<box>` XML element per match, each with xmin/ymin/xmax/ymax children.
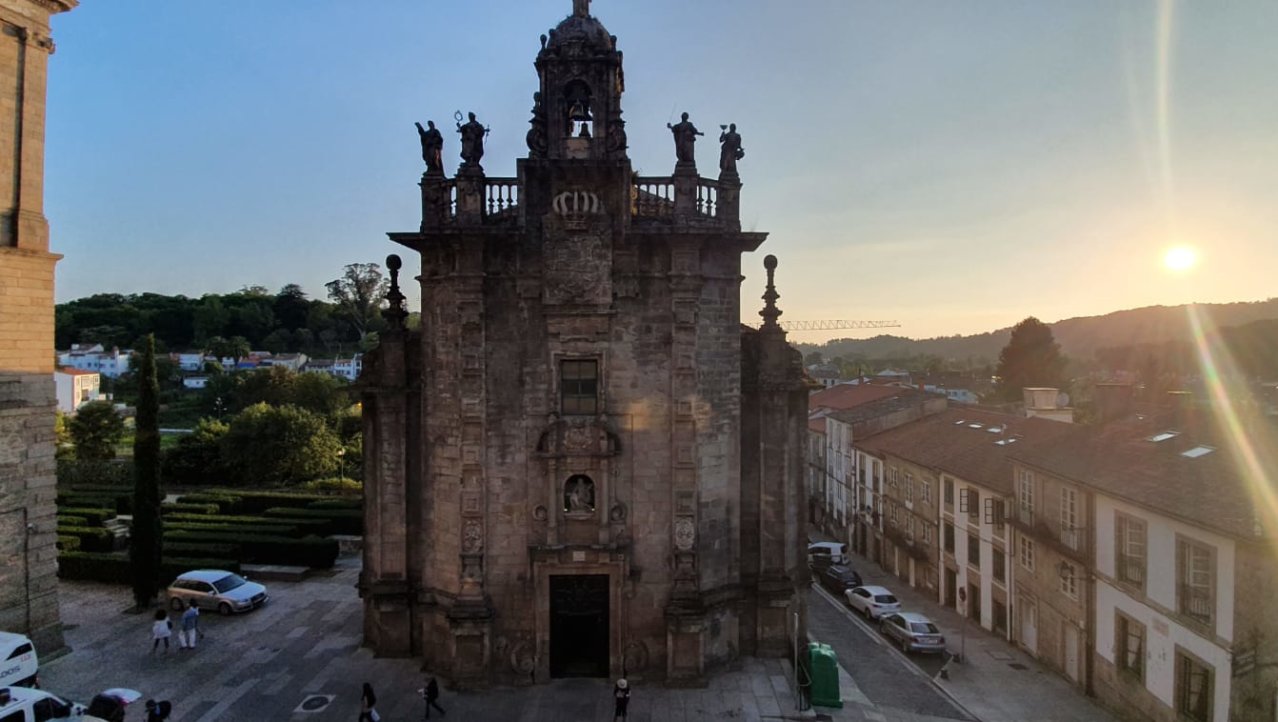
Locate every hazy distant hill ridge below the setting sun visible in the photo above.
<box><xmin>795</xmin><ymin>298</ymin><xmax>1278</xmax><ymax>362</ymax></box>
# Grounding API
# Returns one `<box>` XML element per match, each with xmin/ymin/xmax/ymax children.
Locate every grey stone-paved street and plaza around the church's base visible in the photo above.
<box><xmin>41</xmin><ymin>546</ymin><xmax>1109</xmax><ymax>722</ymax></box>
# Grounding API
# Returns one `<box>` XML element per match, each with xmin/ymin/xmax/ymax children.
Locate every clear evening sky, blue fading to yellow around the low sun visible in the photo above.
<box><xmin>45</xmin><ymin>0</ymin><xmax>1278</xmax><ymax>342</ymax></box>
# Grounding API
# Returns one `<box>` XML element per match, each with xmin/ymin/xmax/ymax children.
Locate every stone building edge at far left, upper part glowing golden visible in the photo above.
<box><xmin>0</xmin><ymin>0</ymin><xmax>77</xmax><ymax>654</ymax></box>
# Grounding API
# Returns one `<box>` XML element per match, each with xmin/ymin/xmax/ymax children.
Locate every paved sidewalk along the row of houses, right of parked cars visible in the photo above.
<box><xmin>828</xmin><ymin>541</ymin><xmax>1117</xmax><ymax>722</ymax></box>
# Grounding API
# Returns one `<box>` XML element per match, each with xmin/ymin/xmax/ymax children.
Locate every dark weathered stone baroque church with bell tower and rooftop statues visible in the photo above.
<box><xmin>359</xmin><ymin>0</ymin><xmax>808</xmax><ymax>686</ymax></box>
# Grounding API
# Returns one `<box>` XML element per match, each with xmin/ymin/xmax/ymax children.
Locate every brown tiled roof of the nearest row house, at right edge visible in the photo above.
<box><xmin>1013</xmin><ymin>414</ymin><xmax>1278</xmax><ymax>538</ymax></box>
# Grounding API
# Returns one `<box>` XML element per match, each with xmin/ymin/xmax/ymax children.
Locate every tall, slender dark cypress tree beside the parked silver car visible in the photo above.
<box><xmin>129</xmin><ymin>336</ymin><xmax>161</xmax><ymax>610</ymax></box>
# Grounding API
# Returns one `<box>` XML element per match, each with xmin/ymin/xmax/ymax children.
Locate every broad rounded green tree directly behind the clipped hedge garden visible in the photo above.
<box><xmin>220</xmin><ymin>404</ymin><xmax>341</xmax><ymax>486</ymax></box>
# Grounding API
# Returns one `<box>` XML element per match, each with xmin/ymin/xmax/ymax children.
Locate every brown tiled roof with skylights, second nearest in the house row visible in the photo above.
<box><xmin>855</xmin><ymin>408</ymin><xmax>1071</xmax><ymax>495</ymax></box>
